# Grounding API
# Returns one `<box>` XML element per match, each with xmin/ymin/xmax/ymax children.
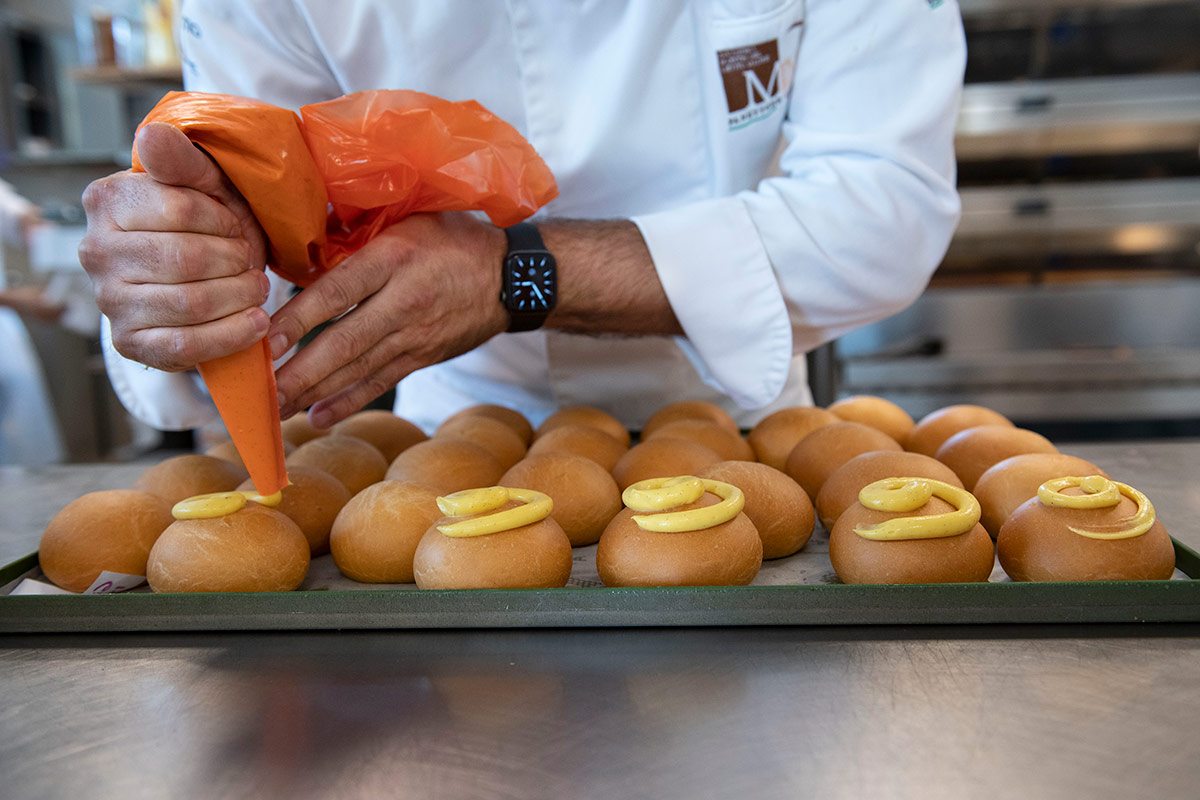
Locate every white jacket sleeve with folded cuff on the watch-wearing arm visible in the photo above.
<box><xmin>635</xmin><ymin>0</ymin><xmax>966</xmax><ymax>408</ymax></box>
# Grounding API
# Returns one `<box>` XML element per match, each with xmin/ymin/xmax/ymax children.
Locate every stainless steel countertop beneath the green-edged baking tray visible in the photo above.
<box><xmin>0</xmin><ymin>441</ymin><xmax>1200</xmax><ymax>799</ymax></box>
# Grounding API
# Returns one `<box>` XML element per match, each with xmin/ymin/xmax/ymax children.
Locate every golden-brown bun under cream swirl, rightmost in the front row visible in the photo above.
<box><xmin>996</xmin><ymin>488</ymin><xmax>1175</xmax><ymax>581</ymax></box>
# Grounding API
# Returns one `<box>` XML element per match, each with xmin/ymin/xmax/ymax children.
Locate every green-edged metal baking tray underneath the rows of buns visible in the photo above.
<box><xmin>0</xmin><ymin>528</ymin><xmax>1200</xmax><ymax>633</ymax></box>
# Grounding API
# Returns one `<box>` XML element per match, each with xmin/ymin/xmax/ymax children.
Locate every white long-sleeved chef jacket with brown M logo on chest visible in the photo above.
<box><xmin>106</xmin><ymin>0</ymin><xmax>965</xmax><ymax>429</ymax></box>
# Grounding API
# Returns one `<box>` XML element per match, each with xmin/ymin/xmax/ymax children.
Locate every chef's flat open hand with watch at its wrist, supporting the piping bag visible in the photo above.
<box><xmin>269</xmin><ymin>212</ymin><xmax>508</xmax><ymax>427</ymax></box>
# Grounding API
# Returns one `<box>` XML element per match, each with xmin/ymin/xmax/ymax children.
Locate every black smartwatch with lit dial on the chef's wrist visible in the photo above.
<box><xmin>500</xmin><ymin>222</ymin><xmax>558</xmax><ymax>333</ymax></box>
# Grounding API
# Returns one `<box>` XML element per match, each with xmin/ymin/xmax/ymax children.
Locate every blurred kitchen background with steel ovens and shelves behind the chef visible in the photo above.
<box><xmin>0</xmin><ymin>0</ymin><xmax>1200</xmax><ymax>461</ymax></box>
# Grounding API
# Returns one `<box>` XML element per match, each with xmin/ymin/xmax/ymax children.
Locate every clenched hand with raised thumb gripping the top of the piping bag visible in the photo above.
<box><xmin>79</xmin><ymin>122</ymin><xmax>270</xmax><ymax>372</ymax></box>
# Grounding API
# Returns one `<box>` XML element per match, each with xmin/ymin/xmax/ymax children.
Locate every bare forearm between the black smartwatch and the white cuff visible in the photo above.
<box><xmin>538</xmin><ymin>219</ymin><xmax>683</xmax><ymax>336</ymax></box>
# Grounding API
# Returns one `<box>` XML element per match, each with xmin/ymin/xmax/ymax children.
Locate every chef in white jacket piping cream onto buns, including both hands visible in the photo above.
<box><xmin>82</xmin><ymin>0</ymin><xmax>965</xmax><ymax>428</ymax></box>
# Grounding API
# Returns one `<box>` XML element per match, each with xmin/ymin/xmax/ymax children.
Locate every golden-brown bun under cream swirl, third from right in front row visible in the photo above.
<box><xmin>596</xmin><ymin>493</ymin><xmax>762</xmax><ymax>587</ymax></box>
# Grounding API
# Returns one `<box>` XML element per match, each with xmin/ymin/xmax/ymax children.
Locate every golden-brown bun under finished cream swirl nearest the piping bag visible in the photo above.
<box><xmin>413</xmin><ymin>517</ymin><xmax>571</xmax><ymax>589</ymax></box>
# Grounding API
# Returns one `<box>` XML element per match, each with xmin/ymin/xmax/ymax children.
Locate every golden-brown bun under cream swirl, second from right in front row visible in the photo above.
<box><xmin>829</xmin><ymin>498</ymin><xmax>995</xmax><ymax>583</ymax></box>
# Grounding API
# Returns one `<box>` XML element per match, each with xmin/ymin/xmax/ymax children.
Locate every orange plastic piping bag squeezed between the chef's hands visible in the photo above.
<box><xmin>133</xmin><ymin>90</ymin><xmax>558</xmax><ymax>494</ymax></box>
